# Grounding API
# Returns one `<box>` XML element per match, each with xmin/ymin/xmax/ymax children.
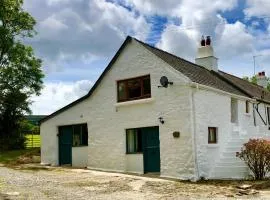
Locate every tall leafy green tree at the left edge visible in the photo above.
<box><xmin>0</xmin><ymin>0</ymin><xmax>44</xmax><ymax>149</ymax></box>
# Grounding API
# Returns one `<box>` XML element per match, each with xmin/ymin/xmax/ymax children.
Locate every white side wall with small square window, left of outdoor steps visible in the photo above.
<box><xmin>194</xmin><ymin>89</ymin><xmax>231</xmax><ymax>178</ymax></box>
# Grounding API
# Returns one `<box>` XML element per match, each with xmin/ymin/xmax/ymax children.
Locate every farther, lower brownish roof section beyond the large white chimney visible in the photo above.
<box><xmin>218</xmin><ymin>71</ymin><xmax>270</xmax><ymax>103</ymax></box>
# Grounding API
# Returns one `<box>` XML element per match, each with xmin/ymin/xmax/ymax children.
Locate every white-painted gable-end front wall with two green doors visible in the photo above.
<box><xmin>41</xmin><ymin>40</ymin><xmax>195</xmax><ymax>179</ymax></box>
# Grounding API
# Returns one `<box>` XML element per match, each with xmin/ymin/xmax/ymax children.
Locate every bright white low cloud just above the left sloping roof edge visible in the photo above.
<box><xmin>31</xmin><ymin>80</ymin><xmax>93</xmax><ymax>114</ymax></box>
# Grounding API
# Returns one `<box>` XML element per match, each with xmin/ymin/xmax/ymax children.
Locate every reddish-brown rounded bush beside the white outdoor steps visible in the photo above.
<box><xmin>236</xmin><ymin>139</ymin><xmax>270</xmax><ymax>180</ymax></box>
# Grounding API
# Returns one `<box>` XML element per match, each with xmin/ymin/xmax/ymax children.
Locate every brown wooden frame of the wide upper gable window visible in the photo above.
<box><xmin>117</xmin><ymin>75</ymin><xmax>151</xmax><ymax>102</ymax></box>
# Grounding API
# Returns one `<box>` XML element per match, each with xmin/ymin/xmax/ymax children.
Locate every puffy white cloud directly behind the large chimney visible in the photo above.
<box><xmin>154</xmin><ymin>0</ymin><xmax>237</xmax><ymax>61</ymax></box>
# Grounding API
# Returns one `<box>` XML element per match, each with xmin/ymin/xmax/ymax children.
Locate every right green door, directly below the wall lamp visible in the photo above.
<box><xmin>141</xmin><ymin>127</ymin><xmax>160</xmax><ymax>173</ymax></box>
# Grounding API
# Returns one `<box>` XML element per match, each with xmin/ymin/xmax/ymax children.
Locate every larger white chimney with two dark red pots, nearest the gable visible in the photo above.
<box><xmin>195</xmin><ymin>36</ymin><xmax>218</xmax><ymax>71</ymax></box>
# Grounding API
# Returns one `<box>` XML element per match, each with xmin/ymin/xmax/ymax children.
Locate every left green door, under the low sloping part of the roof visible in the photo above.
<box><xmin>59</xmin><ymin>126</ymin><xmax>72</xmax><ymax>165</ymax></box>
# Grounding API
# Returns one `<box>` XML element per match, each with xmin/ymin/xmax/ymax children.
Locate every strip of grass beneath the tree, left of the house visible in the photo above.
<box><xmin>0</xmin><ymin>148</ymin><xmax>40</xmax><ymax>165</ymax></box>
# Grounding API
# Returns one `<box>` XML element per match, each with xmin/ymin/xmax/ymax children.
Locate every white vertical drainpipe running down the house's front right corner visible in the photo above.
<box><xmin>191</xmin><ymin>84</ymin><xmax>200</xmax><ymax>181</ymax></box>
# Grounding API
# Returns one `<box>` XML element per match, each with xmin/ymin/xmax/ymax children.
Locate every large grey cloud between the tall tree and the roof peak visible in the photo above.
<box><xmin>25</xmin><ymin>0</ymin><xmax>150</xmax><ymax>72</ymax></box>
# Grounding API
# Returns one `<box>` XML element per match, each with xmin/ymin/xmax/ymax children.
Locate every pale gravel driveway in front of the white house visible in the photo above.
<box><xmin>0</xmin><ymin>167</ymin><xmax>270</xmax><ymax>200</ymax></box>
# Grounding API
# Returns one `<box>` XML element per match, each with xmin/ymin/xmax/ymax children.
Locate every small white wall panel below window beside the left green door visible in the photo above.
<box><xmin>72</xmin><ymin>146</ymin><xmax>88</xmax><ymax>167</ymax></box>
